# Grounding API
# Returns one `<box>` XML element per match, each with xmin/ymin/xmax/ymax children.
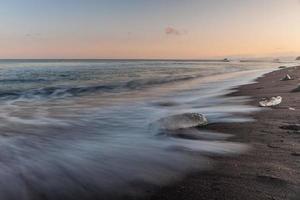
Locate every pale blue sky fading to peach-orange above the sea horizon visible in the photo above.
<box><xmin>0</xmin><ymin>0</ymin><xmax>300</xmax><ymax>59</ymax></box>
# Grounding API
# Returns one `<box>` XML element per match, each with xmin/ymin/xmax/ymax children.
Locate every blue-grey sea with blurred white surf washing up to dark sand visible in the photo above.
<box><xmin>0</xmin><ymin>60</ymin><xmax>294</xmax><ymax>200</ymax></box>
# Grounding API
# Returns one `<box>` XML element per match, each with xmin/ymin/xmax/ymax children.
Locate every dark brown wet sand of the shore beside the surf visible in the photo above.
<box><xmin>146</xmin><ymin>67</ymin><xmax>300</xmax><ymax>200</ymax></box>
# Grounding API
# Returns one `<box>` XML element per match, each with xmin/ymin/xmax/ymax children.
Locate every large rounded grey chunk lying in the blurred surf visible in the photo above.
<box><xmin>159</xmin><ymin>113</ymin><xmax>208</xmax><ymax>130</ymax></box>
